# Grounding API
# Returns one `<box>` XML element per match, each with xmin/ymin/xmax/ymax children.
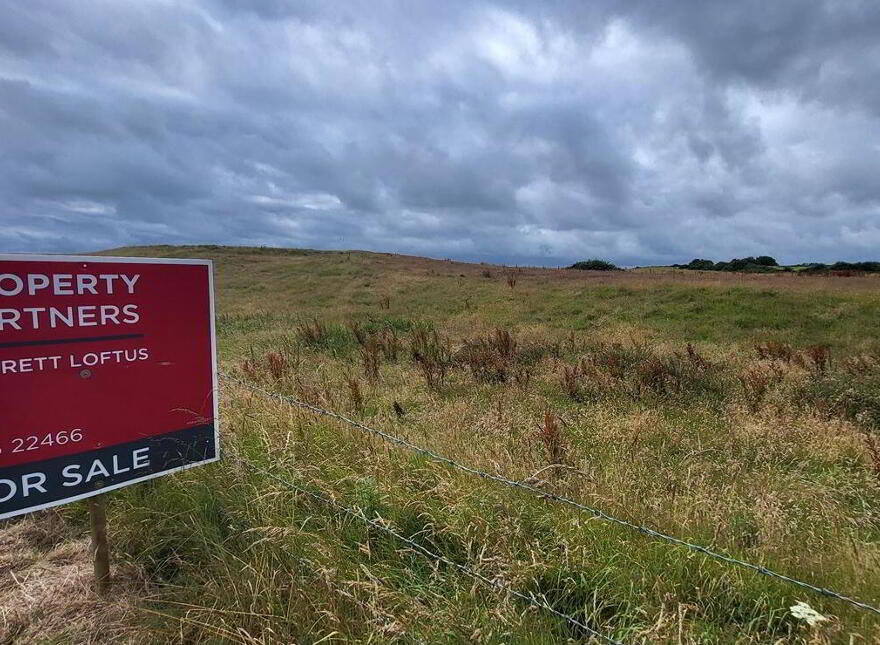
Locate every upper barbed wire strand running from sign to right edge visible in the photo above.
<box><xmin>223</xmin><ymin>374</ymin><xmax>880</xmax><ymax>616</ymax></box>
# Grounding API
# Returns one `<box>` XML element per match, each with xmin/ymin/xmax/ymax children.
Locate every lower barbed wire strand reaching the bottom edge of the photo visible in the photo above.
<box><xmin>250</xmin><ymin>464</ymin><xmax>624</xmax><ymax>645</ymax></box>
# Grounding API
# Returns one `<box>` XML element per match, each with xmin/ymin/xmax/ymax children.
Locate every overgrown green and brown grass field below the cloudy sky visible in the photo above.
<box><xmin>0</xmin><ymin>247</ymin><xmax>880</xmax><ymax>643</ymax></box>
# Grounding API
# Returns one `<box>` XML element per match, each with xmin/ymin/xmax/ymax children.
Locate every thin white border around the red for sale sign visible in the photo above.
<box><xmin>0</xmin><ymin>253</ymin><xmax>220</xmax><ymax>520</ymax></box>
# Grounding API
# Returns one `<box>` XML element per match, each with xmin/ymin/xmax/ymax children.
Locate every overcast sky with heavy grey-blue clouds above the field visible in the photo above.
<box><xmin>0</xmin><ymin>0</ymin><xmax>880</xmax><ymax>265</ymax></box>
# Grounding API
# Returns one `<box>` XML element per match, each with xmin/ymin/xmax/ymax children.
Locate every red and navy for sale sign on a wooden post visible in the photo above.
<box><xmin>0</xmin><ymin>254</ymin><xmax>219</xmax><ymax>519</ymax></box>
